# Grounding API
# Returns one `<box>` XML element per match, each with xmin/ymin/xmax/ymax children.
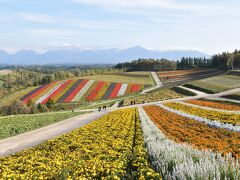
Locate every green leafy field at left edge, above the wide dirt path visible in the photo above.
<box><xmin>0</xmin><ymin>112</ymin><xmax>82</xmax><ymax>139</ymax></box>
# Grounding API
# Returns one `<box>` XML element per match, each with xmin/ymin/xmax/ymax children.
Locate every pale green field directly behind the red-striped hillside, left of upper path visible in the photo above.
<box><xmin>82</xmin><ymin>72</ymin><xmax>154</xmax><ymax>85</ymax></box>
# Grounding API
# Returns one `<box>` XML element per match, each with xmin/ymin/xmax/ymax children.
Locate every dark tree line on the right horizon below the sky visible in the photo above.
<box><xmin>115</xmin><ymin>50</ymin><xmax>240</xmax><ymax>71</ymax></box>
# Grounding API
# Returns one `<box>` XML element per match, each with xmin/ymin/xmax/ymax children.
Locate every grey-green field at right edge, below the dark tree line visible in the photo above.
<box><xmin>184</xmin><ymin>75</ymin><xmax>240</xmax><ymax>94</ymax></box>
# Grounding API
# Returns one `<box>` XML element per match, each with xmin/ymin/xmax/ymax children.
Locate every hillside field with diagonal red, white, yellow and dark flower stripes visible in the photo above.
<box><xmin>21</xmin><ymin>79</ymin><xmax>144</xmax><ymax>104</ymax></box>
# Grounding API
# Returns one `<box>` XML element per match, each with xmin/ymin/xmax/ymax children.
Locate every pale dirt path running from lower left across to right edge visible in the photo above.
<box><xmin>0</xmin><ymin>85</ymin><xmax>240</xmax><ymax>156</ymax></box>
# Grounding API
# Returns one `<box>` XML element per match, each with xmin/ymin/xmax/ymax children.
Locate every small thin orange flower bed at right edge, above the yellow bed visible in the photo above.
<box><xmin>186</xmin><ymin>100</ymin><xmax>240</xmax><ymax>111</ymax></box>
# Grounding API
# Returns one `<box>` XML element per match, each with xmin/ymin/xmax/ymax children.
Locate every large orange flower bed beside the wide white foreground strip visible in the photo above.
<box><xmin>144</xmin><ymin>106</ymin><xmax>240</xmax><ymax>158</ymax></box>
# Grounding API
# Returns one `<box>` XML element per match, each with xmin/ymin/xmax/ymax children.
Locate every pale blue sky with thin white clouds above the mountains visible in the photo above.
<box><xmin>0</xmin><ymin>0</ymin><xmax>240</xmax><ymax>54</ymax></box>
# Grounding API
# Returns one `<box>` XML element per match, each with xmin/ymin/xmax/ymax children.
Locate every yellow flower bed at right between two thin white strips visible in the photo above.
<box><xmin>165</xmin><ymin>102</ymin><xmax>240</xmax><ymax>125</ymax></box>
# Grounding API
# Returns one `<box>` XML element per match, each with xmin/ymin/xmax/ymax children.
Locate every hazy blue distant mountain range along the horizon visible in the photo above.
<box><xmin>0</xmin><ymin>46</ymin><xmax>209</xmax><ymax>65</ymax></box>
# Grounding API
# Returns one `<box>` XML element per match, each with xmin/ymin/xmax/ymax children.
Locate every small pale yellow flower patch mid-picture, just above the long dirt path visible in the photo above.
<box><xmin>124</xmin><ymin>89</ymin><xmax>183</xmax><ymax>106</ymax></box>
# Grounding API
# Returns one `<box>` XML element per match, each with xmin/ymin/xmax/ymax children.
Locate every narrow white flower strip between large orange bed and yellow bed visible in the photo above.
<box><xmin>157</xmin><ymin>103</ymin><xmax>240</xmax><ymax>132</ymax></box>
